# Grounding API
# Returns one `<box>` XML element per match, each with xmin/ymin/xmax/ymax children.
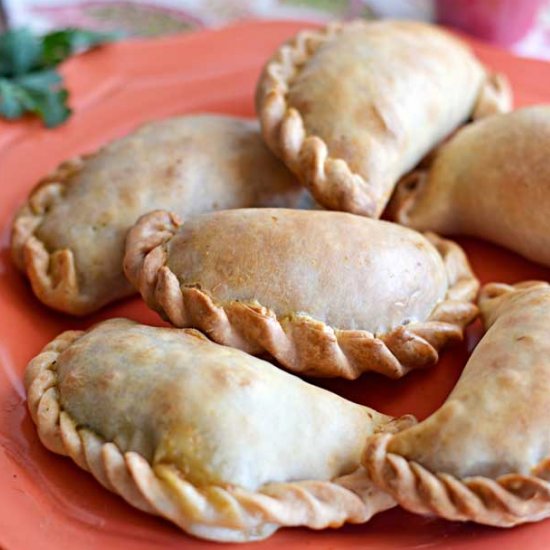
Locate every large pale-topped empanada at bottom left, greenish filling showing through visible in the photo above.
<box><xmin>25</xmin><ymin>319</ymin><xmax>413</xmax><ymax>541</ymax></box>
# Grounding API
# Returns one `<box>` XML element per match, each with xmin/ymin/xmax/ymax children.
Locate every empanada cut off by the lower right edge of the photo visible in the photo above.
<box><xmin>365</xmin><ymin>282</ymin><xmax>550</xmax><ymax>527</ymax></box>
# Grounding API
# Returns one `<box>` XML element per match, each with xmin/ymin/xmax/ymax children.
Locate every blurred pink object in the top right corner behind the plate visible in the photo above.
<box><xmin>436</xmin><ymin>0</ymin><xmax>548</xmax><ymax>46</ymax></box>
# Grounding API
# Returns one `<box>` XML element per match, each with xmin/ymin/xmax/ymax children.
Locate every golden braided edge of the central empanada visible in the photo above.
<box><xmin>124</xmin><ymin>211</ymin><xmax>478</xmax><ymax>379</ymax></box>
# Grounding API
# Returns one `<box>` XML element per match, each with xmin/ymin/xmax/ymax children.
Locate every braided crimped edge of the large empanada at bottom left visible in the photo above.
<box><xmin>25</xmin><ymin>331</ymin><xmax>414</xmax><ymax>542</ymax></box>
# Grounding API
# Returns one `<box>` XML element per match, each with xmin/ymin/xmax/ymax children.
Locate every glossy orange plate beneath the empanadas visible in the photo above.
<box><xmin>0</xmin><ymin>22</ymin><xmax>550</xmax><ymax>550</ymax></box>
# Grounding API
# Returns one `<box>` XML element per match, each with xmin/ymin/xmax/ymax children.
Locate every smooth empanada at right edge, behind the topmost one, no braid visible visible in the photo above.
<box><xmin>391</xmin><ymin>106</ymin><xmax>550</xmax><ymax>266</ymax></box>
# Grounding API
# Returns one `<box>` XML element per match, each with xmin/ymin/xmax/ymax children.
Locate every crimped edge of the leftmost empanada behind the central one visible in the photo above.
<box><xmin>11</xmin><ymin>156</ymin><xmax>97</xmax><ymax>315</ymax></box>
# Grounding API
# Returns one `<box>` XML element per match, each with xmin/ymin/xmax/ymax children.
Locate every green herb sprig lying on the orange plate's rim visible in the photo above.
<box><xmin>0</xmin><ymin>28</ymin><xmax>120</xmax><ymax>128</ymax></box>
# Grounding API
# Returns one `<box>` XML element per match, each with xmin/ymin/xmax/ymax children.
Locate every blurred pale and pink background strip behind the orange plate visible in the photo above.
<box><xmin>0</xmin><ymin>0</ymin><xmax>550</xmax><ymax>59</ymax></box>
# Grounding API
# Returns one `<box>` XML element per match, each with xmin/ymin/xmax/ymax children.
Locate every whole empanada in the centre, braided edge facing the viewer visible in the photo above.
<box><xmin>124</xmin><ymin>208</ymin><xmax>478</xmax><ymax>378</ymax></box>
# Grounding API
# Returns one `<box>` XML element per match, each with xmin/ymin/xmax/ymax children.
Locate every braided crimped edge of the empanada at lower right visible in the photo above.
<box><xmin>363</xmin><ymin>282</ymin><xmax>550</xmax><ymax>527</ymax></box>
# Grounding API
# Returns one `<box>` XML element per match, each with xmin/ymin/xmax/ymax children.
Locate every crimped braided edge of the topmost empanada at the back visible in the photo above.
<box><xmin>256</xmin><ymin>20</ymin><xmax>512</xmax><ymax>217</ymax></box>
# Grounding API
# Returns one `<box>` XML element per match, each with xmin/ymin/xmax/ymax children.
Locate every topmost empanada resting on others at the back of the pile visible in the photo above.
<box><xmin>256</xmin><ymin>21</ymin><xmax>511</xmax><ymax>217</ymax></box>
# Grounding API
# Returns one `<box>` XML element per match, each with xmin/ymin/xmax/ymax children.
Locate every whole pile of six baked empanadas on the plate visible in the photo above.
<box><xmin>12</xmin><ymin>21</ymin><xmax>550</xmax><ymax>541</ymax></box>
